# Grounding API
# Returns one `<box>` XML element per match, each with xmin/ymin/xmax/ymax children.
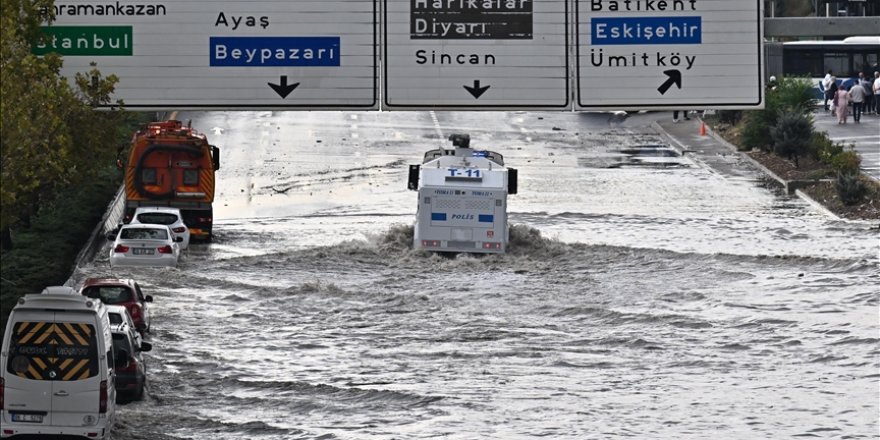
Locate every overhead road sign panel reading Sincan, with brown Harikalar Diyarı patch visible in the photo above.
<box><xmin>382</xmin><ymin>0</ymin><xmax>571</xmax><ymax>110</ymax></box>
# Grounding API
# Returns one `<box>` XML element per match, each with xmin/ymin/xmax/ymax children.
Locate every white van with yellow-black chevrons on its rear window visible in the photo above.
<box><xmin>0</xmin><ymin>286</ymin><xmax>116</xmax><ymax>439</ymax></box>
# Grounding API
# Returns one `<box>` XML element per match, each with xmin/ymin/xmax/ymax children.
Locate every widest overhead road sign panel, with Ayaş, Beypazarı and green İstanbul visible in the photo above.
<box><xmin>34</xmin><ymin>0</ymin><xmax>379</xmax><ymax>110</ymax></box>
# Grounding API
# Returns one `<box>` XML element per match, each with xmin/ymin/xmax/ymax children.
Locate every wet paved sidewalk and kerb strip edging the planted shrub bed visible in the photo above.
<box><xmin>651</xmin><ymin>116</ymin><xmax>840</xmax><ymax>219</ymax></box>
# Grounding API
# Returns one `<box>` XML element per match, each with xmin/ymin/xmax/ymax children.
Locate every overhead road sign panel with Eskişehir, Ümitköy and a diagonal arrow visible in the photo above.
<box><xmin>575</xmin><ymin>0</ymin><xmax>764</xmax><ymax>110</ymax></box>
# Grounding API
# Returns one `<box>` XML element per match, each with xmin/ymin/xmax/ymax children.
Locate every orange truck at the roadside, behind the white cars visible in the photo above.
<box><xmin>123</xmin><ymin>120</ymin><xmax>220</xmax><ymax>240</ymax></box>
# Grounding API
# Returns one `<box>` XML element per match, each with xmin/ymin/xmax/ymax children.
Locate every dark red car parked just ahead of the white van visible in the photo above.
<box><xmin>80</xmin><ymin>278</ymin><xmax>153</xmax><ymax>333</ymax></box>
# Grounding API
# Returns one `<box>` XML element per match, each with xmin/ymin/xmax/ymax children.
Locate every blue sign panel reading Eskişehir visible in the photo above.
<box><xmin>591</xmin><ymin>17</ymin><xmax>703</xmax><ymax>46</ymax></box>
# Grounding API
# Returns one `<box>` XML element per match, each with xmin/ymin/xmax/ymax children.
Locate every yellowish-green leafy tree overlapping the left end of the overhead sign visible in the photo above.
<box><xmin>0</xmin><ymin>0</ymin><xmax>125</xmax><ymax>248</ymax></box>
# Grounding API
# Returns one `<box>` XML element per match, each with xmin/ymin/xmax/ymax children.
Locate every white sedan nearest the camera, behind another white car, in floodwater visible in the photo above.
<box><xmin>107</xmin><ymin>224</ymin><xmax>183</xmax><ymax>267</ymax></box>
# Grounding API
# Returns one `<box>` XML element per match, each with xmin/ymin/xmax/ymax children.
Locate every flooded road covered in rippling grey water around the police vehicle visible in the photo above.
<box><xmin>75</xmin><ymin>112</ymin><xmax>880</xmax><ymax>440</ymax></box>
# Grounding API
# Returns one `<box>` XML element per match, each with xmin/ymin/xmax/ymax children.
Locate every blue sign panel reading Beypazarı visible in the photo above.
<box><xmin>210</xmin><ymin>37</ymin><xmax>340</xmax><ymax>67</ymax></box>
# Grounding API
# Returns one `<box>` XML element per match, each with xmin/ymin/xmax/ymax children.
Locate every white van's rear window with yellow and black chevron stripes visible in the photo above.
<box><xmin>6</xmin><ymin>321</ymin><xmax>98</xmax><ymax>381</ymax></box>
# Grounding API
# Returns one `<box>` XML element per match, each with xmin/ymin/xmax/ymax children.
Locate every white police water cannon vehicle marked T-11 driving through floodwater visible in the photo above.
<box><xmin>407</xmin><ymin>134</ymin><xmax>517</xmax><ymax>253</ymax></box>
